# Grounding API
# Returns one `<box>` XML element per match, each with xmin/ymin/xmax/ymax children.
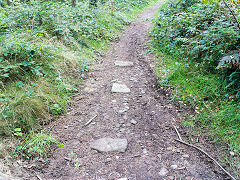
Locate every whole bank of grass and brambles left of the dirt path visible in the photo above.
<box><xmin>0</xmin><ymin>0</ymin><xmax>158</xmax><ymax>157</ymax></box>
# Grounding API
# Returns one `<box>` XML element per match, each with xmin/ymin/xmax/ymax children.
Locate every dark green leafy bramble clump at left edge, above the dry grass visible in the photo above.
<box><xmin>0</xmin><ymin>34</ymin><xmax>54</xmax><ymax>82</ymax></box>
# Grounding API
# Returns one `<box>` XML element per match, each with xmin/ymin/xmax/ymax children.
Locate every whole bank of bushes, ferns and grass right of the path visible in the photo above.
<box><xmin>151</xmin><ymin>0</ymin><xmax>240</xmax><ymax>174</ymax></box>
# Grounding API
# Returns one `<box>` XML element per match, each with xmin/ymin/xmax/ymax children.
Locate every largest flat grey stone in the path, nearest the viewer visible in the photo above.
<box><xmin>90</xmin><ymin>138</ymin><xmax>128</xmax><ymax>152</ymax></box>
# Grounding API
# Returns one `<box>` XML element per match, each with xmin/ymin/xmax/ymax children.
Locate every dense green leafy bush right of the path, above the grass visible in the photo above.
<box><xmin>153</xmin><ymin>1</ymin><xmax>240</xmax><ymax>68</ymax></box>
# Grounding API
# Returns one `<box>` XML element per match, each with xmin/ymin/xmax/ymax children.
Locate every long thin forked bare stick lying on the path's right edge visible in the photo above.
<box><xmin>173</xmin><ymin>126</ymin><xmax>236</xmax><ymax>180</ymax></box>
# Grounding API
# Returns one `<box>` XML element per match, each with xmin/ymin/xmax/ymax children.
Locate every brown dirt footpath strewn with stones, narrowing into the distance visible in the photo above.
<box><xmin>19</xmin><ymin>2</ymin><xmax>229</xmax><ymax>180</ymax></box>
